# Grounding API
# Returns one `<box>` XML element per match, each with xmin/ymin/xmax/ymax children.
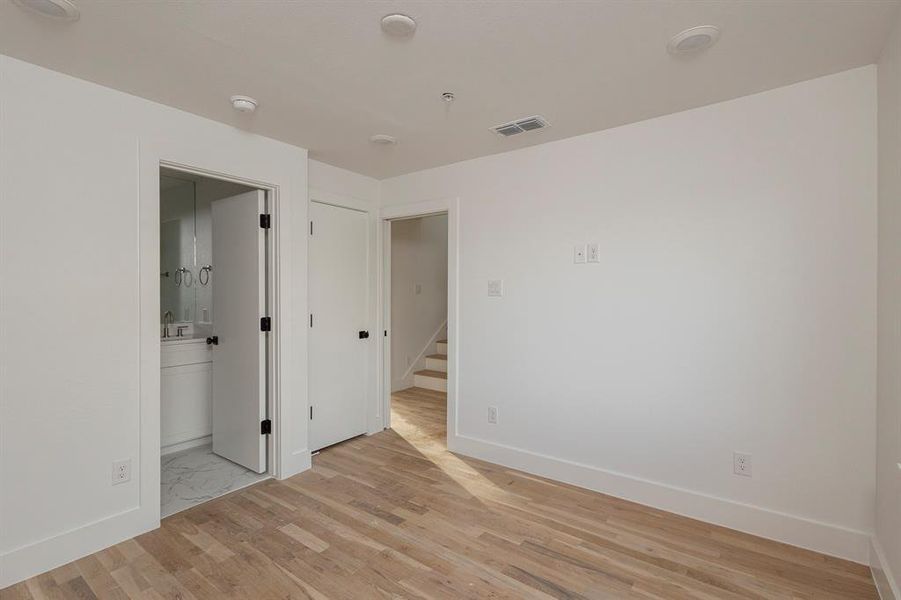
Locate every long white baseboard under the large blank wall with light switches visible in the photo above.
<box><xmin>448</xmin><ymin>436</ymin><xmax>872</xmax><ymax>564</ymax></box>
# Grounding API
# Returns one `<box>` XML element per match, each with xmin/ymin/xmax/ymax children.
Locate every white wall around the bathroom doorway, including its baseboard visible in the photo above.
<box><xmin>0</xmin><ymin>56</ymin><xmax>309</xmax><ymax>587</ymax></box>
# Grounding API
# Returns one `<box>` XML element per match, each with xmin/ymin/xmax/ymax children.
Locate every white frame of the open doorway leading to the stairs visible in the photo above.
<box><xmin>378</xmin><ymin>197</ymin><xmax>460</xmax><ymax>451</ymax></box>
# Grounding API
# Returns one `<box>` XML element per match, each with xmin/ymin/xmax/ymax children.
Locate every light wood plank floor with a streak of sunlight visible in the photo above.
<box><xmin>0</xmin><ymin>388</ymin><xmax>877</xmax><ymax>600</ymax></box>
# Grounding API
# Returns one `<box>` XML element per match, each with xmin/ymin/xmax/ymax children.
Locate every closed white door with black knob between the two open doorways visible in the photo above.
<box><xmin>309</xmin><ymin>202</ymin><xmax>366</xmax><ymax>450</ymax></box>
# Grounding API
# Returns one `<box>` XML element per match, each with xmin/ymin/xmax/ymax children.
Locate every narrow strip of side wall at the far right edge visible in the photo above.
<box><xmin>873</xmin><ymin>7</ymin><xmax>901</xmax><ymax>600</ymax></box>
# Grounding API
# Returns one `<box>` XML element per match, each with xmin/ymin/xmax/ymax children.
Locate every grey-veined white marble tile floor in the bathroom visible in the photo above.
<box><xmin>160</xmin><ymin>446</ymin><xmax>269</xmax><ymax>518</ymax></box>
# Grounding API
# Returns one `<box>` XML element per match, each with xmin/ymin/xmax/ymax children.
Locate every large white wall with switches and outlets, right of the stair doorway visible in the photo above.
<box><xmin>382</xmin><ymin>67</ymin><xmax>876</xmax><ymax>562</ymax></box>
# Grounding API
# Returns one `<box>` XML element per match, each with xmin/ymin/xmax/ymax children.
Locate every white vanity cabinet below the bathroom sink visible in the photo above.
<box><xmin>160</xmin><ymin>338</ymin><xmax>213</xmax><ymax>454</ymax></box>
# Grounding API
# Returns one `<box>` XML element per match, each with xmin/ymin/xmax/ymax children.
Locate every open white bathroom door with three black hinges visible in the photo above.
<box><xmin>212</xmin><ymin>190</ymin><xmax>266</xmax><ymax>473</ymax></box>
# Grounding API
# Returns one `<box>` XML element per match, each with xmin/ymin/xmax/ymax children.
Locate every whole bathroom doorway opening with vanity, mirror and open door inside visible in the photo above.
<box><xmin>160</xmin><ymin>167</ymin><xmax>272</xmax><ymax>517</ymax></box>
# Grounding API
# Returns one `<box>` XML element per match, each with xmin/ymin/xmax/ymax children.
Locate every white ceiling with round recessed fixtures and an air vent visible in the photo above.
<box><xmin>0</xmin><ymin>0</ymin><xmax>898</xmax><ymax>178</ymax></box>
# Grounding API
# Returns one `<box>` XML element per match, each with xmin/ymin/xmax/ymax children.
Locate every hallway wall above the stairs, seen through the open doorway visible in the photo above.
<box><xmin>390</xmin><ymin>215</ymin><xmax>447</xmax><ymax>390</ymax></box>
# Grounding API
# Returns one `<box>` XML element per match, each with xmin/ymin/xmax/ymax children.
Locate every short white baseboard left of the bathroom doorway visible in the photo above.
<box><xmin>0</xmin><ymin>506</ymin><xmax>159</xmax><ymax>589</ymax></box>
